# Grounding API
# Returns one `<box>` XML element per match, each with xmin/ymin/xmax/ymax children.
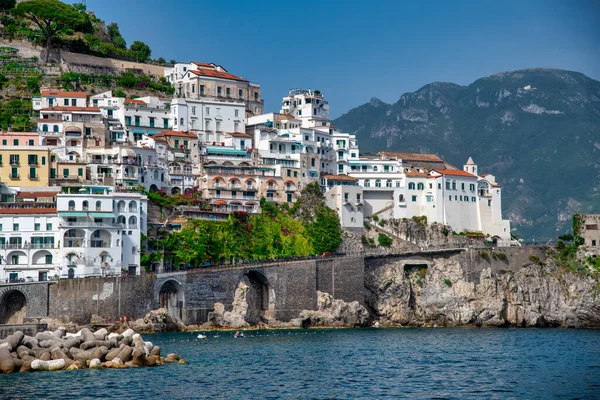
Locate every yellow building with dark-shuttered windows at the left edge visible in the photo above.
<box><xmin>0</xmin><ymin>146</ymin><xmax>50</xmax><ymax>187</ymax></box>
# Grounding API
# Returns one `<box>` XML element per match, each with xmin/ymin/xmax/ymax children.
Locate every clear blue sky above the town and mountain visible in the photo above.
<box><xmin>87</xmin><ymin>0</ymin><xmax>600</xmax><ymax>117</ymax></box>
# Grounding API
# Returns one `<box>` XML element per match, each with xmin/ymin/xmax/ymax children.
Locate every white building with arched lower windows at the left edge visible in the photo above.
<box><xmin>0</xmin><ymin>191</ymin><xmax>61</xmax><ymax>282</ymax></box>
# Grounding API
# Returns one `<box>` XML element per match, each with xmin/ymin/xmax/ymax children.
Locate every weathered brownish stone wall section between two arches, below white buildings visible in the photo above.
<box><xmin>49</xmin><ymin>275</ymin><xmax>155</xmax><ymax>324</ymax></box>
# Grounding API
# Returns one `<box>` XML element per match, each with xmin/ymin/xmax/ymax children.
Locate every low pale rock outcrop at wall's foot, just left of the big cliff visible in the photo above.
<box><xmin>293</xmin><ymin>292</ymin><xmax>369</xmax><ymax>327</ymax></box>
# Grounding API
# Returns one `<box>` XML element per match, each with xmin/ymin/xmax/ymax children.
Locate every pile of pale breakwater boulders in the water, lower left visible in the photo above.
<box><xmin>0</xmin><ymin>328</ymin><xmax>185</xmax><ymax>374</ymax></box>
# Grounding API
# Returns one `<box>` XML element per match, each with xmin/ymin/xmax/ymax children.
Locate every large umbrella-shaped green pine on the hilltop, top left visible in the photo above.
<box><xmin>14</xmin><ymin>0</ymin><xmax>92</xmax><ymax>62</ymax></box>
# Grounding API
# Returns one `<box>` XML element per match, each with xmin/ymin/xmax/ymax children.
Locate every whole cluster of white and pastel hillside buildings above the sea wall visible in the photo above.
<box><xmin>0</xmin><ymin>62</ymin><xmax>510</xmax><ymax>282</ymax></box>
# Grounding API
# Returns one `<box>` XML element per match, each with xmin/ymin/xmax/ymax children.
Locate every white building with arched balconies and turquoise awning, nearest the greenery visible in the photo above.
<box><xmin>56</xmin><ymin>186</ymin><xmax>148</xmax><ymax>278</ymax></box>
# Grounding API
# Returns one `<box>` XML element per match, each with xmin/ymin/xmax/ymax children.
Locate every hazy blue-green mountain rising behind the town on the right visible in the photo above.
<box><xmin>334</xmin><ymin>68</ymin><xmax>600</xmax><ymax>240</ymax></box>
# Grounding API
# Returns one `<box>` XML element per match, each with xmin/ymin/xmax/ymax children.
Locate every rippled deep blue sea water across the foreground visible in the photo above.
<box><xmin>0</xmin><ymin>329</ymin><xmax>600</xmax><ymax>399</ymax></box>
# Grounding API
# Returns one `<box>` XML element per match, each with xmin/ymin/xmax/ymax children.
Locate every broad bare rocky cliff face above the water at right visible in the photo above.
<box><xmin>365</xmin><ymin>253</ymin><xmax>600</xmax><ymax>327</ymax></box>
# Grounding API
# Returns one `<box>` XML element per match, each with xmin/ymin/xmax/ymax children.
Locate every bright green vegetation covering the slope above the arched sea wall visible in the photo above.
<box><xmin>142</xmin><ymin>183</ymin><xmax>342</xmax><ymax>268</ymax></box>
